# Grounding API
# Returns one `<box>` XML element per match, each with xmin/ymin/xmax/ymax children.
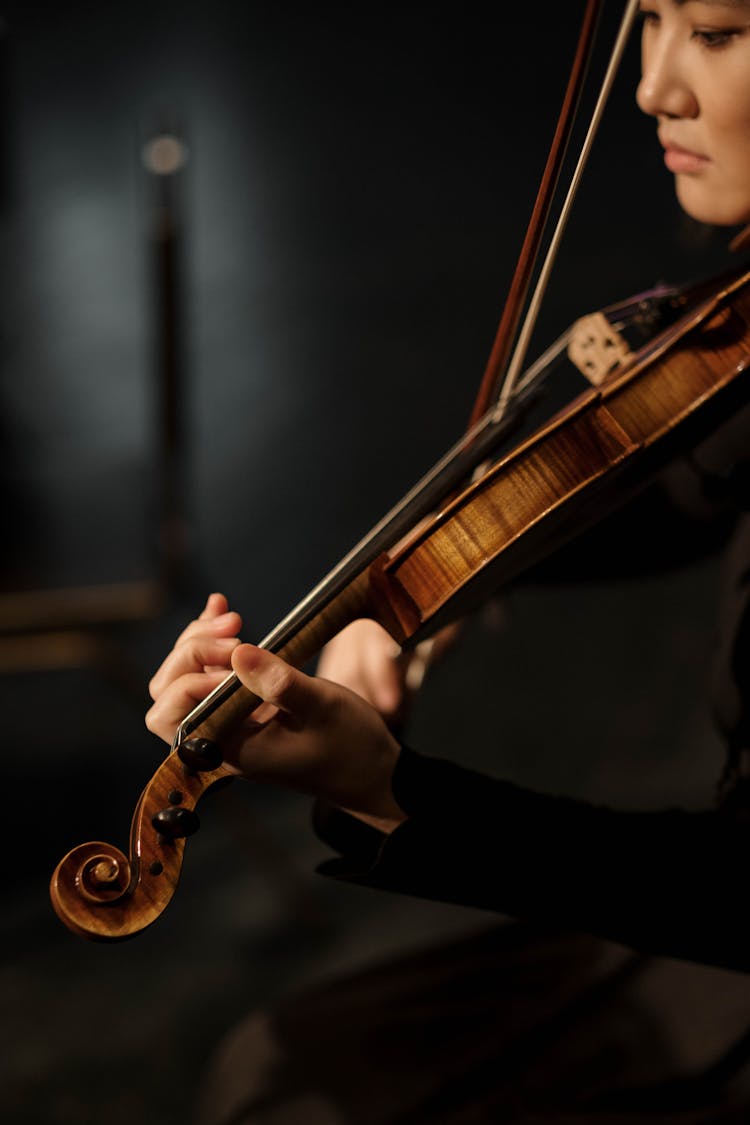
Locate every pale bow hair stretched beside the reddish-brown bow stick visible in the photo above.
<box><xmin>495</xmin><ymin>0</ymin><xmax>639</xmax><ymax>417</ymax></box>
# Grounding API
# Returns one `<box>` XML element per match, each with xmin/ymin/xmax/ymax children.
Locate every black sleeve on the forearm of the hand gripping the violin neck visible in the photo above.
<box><xmin>316</xmin><ymin>749</ymin><xmax>750</xmax><ymax>971</ymax></box>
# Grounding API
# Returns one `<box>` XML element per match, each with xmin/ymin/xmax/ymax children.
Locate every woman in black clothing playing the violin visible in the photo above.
<box><xmin>146</xmin><ymin>0</ymin><xmax>750</xmax><ymax>1121</ymax></box>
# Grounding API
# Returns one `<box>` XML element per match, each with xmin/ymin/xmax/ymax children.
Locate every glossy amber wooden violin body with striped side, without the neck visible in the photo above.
<box><xmin>376</xmin><ymin>266</ymin><xmax>750</xmax><ymax>645</ymax></box>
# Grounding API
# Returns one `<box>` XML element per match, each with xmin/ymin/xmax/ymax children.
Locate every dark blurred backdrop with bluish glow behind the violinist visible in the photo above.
<box><xmin>0</xmin><ymin>0</ymin><xmax>742</xmax><ymax>1125</ymax></box>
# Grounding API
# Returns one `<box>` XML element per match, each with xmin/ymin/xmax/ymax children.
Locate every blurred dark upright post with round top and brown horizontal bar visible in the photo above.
<box><xmin>0</xmin><ymin>111</ymin><xmax>196</xmax><ymax>704</ymax></box>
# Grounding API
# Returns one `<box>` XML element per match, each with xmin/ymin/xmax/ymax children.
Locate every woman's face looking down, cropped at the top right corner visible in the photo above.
<box><xmin>638</xmin><ymin>0</ymin><xmax>750</xmax><ymax>225</ymax></box>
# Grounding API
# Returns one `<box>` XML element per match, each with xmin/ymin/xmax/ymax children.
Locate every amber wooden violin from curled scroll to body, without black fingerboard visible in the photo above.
<box><xmin>51</xmin><ymin>263</ymin><xmax>750</xmax><ymax>941</ymax></box>
